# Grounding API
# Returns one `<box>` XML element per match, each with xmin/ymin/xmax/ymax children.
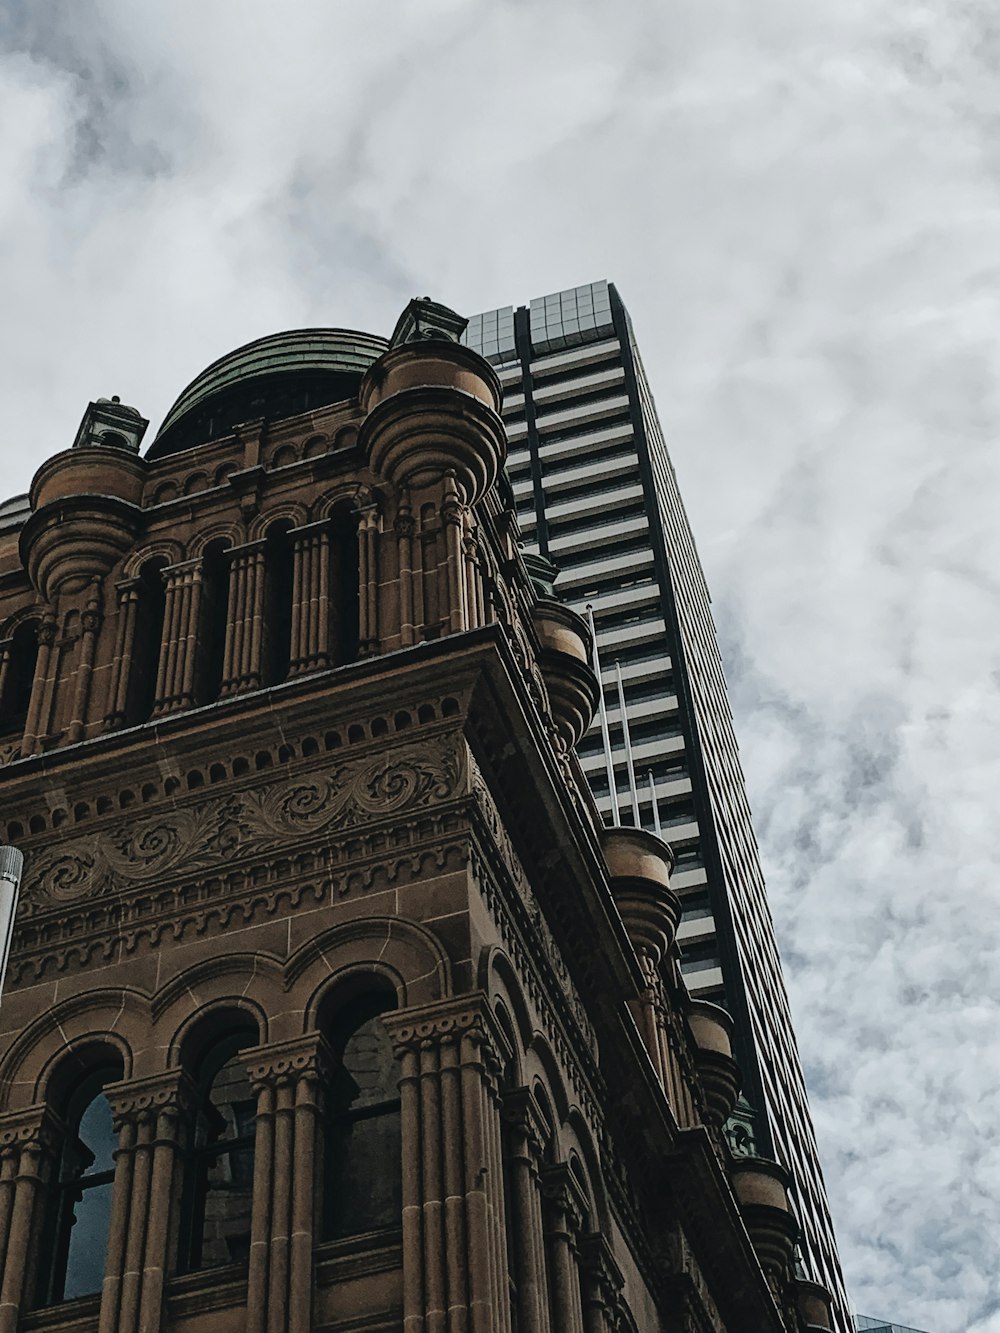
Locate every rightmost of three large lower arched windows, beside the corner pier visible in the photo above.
<box><xmin>323</xmin><ymin>993</ymin><xmax>403</xmax><ymax>1240</ymax></box>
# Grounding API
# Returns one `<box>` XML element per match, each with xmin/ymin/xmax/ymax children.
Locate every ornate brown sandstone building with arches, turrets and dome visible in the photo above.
<box><xmin>0</xmin><ymin>301</ymin><xmax>829</xmax><ymax>1333</ymax></box>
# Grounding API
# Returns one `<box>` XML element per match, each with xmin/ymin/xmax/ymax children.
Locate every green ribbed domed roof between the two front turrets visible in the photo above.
<box><xmin>147</xmin><ymin>329</ymin><xmax>388</xmax><ymax>459</ymax></box>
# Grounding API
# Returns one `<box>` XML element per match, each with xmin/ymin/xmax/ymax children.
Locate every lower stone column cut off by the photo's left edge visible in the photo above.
<box><xmin>0</xmin><ymin>1105</ymin><xmax>65</xmax><ymax>1333</ymax></box>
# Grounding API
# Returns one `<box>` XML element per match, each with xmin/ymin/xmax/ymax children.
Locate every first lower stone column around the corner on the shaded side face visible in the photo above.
<box><xmin>503</xmin><ymin>1088</ymin><xmax>549</xmax><ymax>1333</ymax></box>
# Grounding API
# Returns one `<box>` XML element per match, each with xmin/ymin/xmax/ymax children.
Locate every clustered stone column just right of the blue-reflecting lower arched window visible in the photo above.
<box><xmin>97</xmin><ymin>1069</ymin><xmax>196</xmax><ymax>1333</ymax></box>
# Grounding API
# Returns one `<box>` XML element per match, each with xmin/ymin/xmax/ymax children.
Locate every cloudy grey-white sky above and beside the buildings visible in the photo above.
<box><xmin>0</xmin><ymin>0</ymin><xmax>1000</xmax><ymax>1333</ymax></box>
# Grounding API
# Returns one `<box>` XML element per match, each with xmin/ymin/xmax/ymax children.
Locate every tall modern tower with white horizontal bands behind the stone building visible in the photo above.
<box><xmin>467</xmin><ymin>283</ymin><xmax>852</xmax><ymax>1333</ymax></box>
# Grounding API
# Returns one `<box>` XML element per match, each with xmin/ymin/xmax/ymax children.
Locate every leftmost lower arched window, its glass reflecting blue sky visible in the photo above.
<box><xmin>39</xmin><ymin>1064</ymin><xmax>121</xmax><ymax>1305</ymax></box>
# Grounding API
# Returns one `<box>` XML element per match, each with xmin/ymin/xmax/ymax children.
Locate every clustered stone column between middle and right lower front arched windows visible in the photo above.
<box><xmin>247</xmin><ymin>1033</ymin><xmax>332</xmax><ymax>1333</ymax></box>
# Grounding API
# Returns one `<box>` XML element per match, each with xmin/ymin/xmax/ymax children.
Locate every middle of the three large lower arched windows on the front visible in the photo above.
<box><xmin>179</xmin><ymin>1024</ymin><xmax>257</xmax><ymax>1272</ymax></box>
